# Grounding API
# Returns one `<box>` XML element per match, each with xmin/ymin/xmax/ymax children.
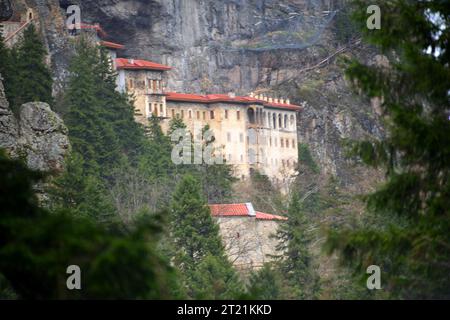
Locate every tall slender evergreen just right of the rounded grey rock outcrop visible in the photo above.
<box><xmin>64</xmin><ymin>39</ymin><xmax>121</xmax><ymax>176</ymax></box>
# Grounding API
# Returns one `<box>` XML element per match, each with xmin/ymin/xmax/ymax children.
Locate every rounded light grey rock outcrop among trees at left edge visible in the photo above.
<box><xmin>0</xmin><ymin>74</ymin><xmax>70</xmax><ymax>172</ymax></box>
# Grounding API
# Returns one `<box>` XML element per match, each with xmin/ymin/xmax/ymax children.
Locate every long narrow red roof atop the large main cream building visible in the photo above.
<box><xmin>166</xmin><ymin>92</ymin><xmax>301</xmax><ymax>111</ymax></box>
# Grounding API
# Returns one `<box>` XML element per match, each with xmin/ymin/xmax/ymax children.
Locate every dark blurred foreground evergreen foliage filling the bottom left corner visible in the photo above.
<box><xmin>0</xmin><ymin>151</ymin><xmax>178</xmax><ymax>299</ymax></box>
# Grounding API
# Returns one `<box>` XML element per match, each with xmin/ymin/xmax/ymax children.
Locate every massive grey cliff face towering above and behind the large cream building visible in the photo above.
<box><xmin>22</xmin><ymin>0</ymin><xmax>383</xmax><ymax>185</ymax></box>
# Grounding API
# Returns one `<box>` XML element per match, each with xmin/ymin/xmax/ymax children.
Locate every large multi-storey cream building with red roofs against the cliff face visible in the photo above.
<box><xmin>111</xmin><ymin>51</ymin><xmax>301</xmax><ymax>183</ymax></box>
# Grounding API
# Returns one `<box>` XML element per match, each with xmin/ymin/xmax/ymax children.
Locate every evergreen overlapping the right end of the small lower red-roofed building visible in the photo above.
<box><xmin>277</xmin><ymin>193</ymin><xmax>320</xmax><ymax>300</ymax></box>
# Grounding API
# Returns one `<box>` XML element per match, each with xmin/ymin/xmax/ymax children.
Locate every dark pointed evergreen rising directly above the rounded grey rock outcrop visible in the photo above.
<box><xmin>8</xmin><ymin>24</ymin><xmax>53</xmax><ymax>110</ymax></box>
